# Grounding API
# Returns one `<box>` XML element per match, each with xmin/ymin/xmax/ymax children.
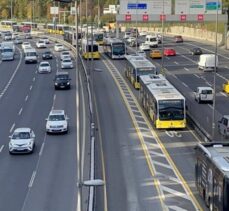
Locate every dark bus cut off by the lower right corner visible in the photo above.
<box><xmin>195</xmin><ymin>141</ymin><xmax>229</xmax><ymax>211</ymax></box>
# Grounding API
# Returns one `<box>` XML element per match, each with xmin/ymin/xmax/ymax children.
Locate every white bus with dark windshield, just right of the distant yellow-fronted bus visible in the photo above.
<box><xmin>103</xmin><ymin>38</ymin><xmax>126</xmax><ymax>59</ymax></box>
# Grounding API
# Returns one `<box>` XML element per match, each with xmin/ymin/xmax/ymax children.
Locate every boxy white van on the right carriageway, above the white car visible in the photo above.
<box><xmin>198</xmin><ymin>54</ymin><xmax>218</xmax><ymax>71</ymax></box>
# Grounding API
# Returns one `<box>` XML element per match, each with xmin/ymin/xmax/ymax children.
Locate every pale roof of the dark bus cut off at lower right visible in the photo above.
<box><xmin>198</xmin><ymin>142</ymin><xmax>229</xmax><ymax>176</ymax></box>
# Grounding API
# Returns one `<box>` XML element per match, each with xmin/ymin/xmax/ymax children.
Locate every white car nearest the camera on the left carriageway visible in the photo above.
<box><xmin>9</xmin><ymin>128</ymin><xmax>35</xmax><ymax>154</ymax></box>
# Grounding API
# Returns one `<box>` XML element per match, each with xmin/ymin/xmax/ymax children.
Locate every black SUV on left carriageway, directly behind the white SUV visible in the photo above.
<box><xmin>54</xmin><ymin>72</ymin><xmax>71</xmax><ymax>89</ymax></box>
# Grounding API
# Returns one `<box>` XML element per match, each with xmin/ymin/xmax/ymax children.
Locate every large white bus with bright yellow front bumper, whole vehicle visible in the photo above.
<box><xmin>140</xmin><ymin>74</ymin><xmax>186</xmax><ymax>129</ymax></box>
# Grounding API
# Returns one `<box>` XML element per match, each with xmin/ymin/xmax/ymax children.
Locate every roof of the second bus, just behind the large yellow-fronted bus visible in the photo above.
<box><xmin>125</xmin><ymin>55</ymin><xmax>156</xmax><ymax>69</ymax></box>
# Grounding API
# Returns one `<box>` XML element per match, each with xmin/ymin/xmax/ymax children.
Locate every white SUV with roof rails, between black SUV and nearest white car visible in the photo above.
<box><xmin>46</xmin><ymin>110</ymin><xmax>69</xmax><ymax>133</ymax></box>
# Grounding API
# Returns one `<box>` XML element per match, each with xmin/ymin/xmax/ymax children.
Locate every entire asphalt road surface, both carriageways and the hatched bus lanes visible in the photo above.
<box><xmin>0</xmin><ymin>31</ymin><xmax>229</xmax><ymax>211</ymax></box>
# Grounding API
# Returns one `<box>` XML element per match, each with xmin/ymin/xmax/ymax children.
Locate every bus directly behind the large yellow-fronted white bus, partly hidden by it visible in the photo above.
<box><xmin>125</xmin><ymin>55</ymin><xmax>157</xmax><ymax>89</ymax></box>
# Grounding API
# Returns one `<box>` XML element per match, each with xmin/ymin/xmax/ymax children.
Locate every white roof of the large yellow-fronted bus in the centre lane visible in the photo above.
<box><xmin>147</xmin><ymin>80</ymin><xmax>185</xmax><ymax>100</ymax></box>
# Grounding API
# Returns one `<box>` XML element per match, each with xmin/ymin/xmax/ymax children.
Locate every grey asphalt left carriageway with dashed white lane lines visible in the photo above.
<box><xmin>0</xmin><ymin>36</ymin><xmax>89</xmax><ymax>211</ymax></box>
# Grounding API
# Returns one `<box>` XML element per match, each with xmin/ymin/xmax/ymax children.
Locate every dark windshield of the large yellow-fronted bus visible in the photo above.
<box><xmin>158</xmin><ymin>100</ymin><xmax>184</xmax><ymax>120</ymax></box>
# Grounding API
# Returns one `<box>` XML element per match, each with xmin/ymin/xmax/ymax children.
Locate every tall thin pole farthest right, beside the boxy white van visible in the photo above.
<box><xmin>212</xmin><ymin>0</ymin><xmax>219</xmax><ymax>141</ymax></box>
